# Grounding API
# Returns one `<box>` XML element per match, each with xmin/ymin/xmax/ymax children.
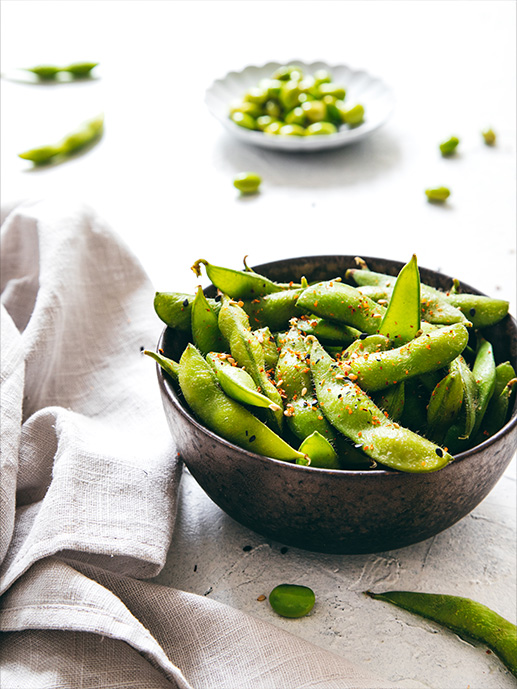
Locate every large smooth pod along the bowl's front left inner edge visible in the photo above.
<box><xmin>179</xmin><ymin>344</ymin><xmax>304</xmax><ymax>462</ymax></box>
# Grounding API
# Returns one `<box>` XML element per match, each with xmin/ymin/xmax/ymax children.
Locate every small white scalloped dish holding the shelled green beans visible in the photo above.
<box><xmin>205</xmin><ymin>60</ymin><xmax>395</xmax><ymax>151</ymax></box>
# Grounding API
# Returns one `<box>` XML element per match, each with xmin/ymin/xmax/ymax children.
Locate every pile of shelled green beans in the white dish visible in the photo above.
<box><xmin>229</xmin><ymin>65</ymin><xmax>364</xmax><ymax>136</ymax></box>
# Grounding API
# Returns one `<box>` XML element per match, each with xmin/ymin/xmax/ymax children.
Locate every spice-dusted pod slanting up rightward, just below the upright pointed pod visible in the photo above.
<box><xmin>341</xmin><ymin>323</ymin><xmax>468</xmax><ymax>391</ymax></box>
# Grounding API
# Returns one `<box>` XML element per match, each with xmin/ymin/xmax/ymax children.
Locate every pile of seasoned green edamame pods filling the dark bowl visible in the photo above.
<box><xmin>146</xmin><ymin>256</ymin><xmax>517</xmax><ymax>472</ymax></box>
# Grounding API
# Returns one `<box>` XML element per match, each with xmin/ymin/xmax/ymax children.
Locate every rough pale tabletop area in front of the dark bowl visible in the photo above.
<box><xmin>155</xmin><ymin>459</ymin><xmax>517</xmax><ymax>689</ymax></box>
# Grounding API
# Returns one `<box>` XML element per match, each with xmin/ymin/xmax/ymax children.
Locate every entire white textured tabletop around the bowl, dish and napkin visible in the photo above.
<box><xmin>1</xmin><ymin>0</ymin><xmax>516</xmax><ymax>689</ymax></box>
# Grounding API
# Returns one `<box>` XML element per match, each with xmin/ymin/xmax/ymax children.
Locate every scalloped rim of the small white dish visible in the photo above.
<box><xmin>204</xmin><ymin>59</ymin><xmax>396</xmax><ymax>151</ymax></box>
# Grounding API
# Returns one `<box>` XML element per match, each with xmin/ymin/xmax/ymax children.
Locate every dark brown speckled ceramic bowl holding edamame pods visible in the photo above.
<box><xmin>158</xmin><ymin>256</ymin><xmax>517</xmax><ymax>553</ymax></box>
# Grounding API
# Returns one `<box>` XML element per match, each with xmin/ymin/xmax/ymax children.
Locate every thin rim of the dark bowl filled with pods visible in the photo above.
<box><xmin>156</xmin><ymin>254</ymin><xmax>517</xmax><ymax>479</ymax></box>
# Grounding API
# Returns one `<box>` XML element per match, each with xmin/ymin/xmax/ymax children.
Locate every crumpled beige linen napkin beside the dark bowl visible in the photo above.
<box><xmin>0</xmin><ymin>202</ymin><xmax>396</xmax><ymax>689</ymax></box>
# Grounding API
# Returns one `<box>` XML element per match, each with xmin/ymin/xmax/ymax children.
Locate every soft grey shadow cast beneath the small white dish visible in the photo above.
<box><xmin>215</xmin><ymin>131</ymin><xmax>402</xmax><ymax>189</ymax></box>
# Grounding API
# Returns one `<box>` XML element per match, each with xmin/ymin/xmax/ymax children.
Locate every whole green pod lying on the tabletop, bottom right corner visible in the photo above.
<box><xmin>366</xmin><ymin>591</ymin><xmax>517</xmax><ymax>677</ymax></box>
